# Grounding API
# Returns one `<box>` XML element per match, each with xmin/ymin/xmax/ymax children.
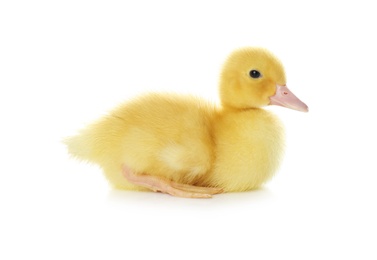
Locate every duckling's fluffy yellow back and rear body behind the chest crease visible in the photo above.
<box><xmin>66</xmin><ymin>94</ymin><xmax>215</xmax><ymax>189</ymax></box>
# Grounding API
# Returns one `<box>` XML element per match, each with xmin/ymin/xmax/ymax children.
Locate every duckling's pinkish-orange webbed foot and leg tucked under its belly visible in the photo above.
<box><xmin>123</xmin><ymin>166</ymin><xmax>222</xmax><ymax>198</ymax></box>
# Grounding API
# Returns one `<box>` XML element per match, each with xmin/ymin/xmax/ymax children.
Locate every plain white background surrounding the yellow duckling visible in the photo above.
<box><xmin>0</xmin><ymin>0</ymin><xmax>377</xmax><ymax>259</ymax></box>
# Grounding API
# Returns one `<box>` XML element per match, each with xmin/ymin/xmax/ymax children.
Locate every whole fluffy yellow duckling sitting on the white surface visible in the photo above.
<box><xmin>65</xmin><ymin>47</ymin><xmax>308</xmax><ymax>198</ymax></box>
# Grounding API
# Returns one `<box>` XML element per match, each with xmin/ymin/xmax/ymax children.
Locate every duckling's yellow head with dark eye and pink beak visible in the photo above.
<box><xmin>220</xmin><ymin>47</ymin><xmax>308</xmax><ymax>112</ymax></box>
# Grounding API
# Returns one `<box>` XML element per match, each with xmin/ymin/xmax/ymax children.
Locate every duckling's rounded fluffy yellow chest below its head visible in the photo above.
<box><xmin>212</xmin><ymin>109</ymin><xmax>284</xmax><ymax>191</ymax></box>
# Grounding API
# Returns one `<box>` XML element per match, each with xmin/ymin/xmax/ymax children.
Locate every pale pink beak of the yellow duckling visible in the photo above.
<box><xmin>270</xmin><ymin>85</ymin><xmax>309</xmax><ymax>112</ymax></box>
